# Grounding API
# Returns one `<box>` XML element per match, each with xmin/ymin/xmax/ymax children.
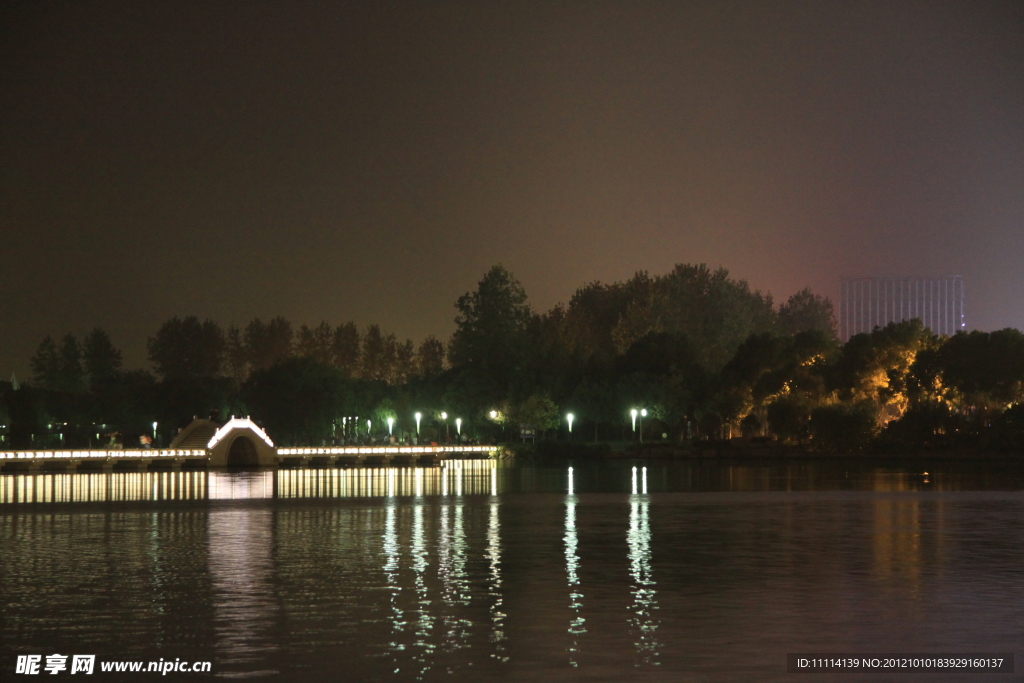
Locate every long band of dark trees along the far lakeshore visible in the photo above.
<box><xmin>0</xmin><ymin>264</ymin><xmax>1024</xmax><ymax>453</ymax></box>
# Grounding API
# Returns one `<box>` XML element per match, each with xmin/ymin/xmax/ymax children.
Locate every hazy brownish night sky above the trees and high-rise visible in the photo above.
<box><xmin>0</xmin><ymin>0</ymin><xmax>1024</xmax><ymax>379</ymax></box>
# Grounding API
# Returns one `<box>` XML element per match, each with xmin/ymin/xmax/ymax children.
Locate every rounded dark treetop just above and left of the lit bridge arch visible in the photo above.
<box><xmin>146</xmin><ymin>315</ymin><xmax>224</xmax><ymax>380</ymax></box>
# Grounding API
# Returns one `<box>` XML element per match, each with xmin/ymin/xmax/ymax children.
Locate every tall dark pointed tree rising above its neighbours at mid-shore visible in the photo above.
<box><xmin>449</xmin><ymin>265</ymin><xmax>530</xmax><ymax>389</ymax></box>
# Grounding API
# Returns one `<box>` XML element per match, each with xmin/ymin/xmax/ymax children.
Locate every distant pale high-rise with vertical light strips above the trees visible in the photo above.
<box><xmin>839</xmin><ymin>275</ymin><xmax>966</xmax><ymax>341</ymax></box>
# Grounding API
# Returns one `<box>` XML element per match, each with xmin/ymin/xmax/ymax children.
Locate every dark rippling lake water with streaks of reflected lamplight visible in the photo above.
<box><xmin>0</xmin><ymin>460</ymin><xmax>1024</xmax><ymax>681</ymax></box>
